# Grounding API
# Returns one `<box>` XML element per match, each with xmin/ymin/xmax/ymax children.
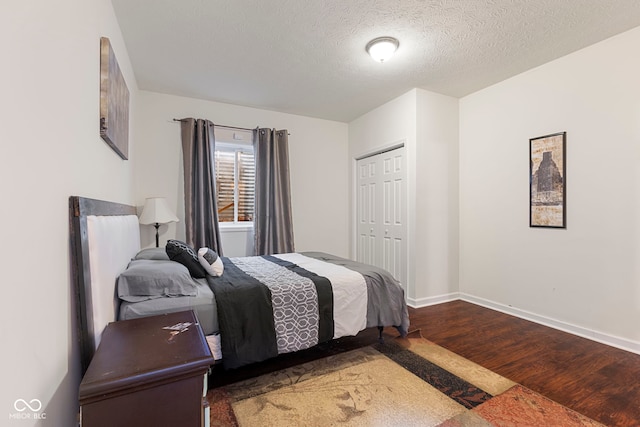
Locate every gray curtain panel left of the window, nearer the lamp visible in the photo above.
<box><xmin>180</xmin><ymin>118</ymin><xmax>222</xmax><ymax>255</ymax></box>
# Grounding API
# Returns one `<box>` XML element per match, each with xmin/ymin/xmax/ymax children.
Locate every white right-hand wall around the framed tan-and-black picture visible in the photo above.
<box><xmin>460</xmin><ymin>28</ymin><xmax>640</xmax><ymax>351</ymax></box>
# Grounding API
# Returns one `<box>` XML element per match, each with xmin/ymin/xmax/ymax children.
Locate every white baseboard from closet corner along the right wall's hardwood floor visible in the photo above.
<box><xmin>407</xmin><ymin>292</ymin><xmax>640</xmax><ymax>354</ymax></box>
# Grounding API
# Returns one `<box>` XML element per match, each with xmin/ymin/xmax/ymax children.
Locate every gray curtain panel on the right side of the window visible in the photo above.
<box><xmin>253</xmin><ymin>129</ymin><xmax>295</xmax><ymax>255</ymax></box>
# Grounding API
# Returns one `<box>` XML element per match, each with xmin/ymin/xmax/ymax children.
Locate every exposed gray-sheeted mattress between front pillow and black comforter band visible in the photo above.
<box><xmin>118</xmin><ymin>279</ymin><xmax>219</xmax><ymax>335</ymax></box>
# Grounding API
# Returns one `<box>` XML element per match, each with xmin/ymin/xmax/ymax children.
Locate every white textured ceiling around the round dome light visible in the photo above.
<box><xmin>112</xmin><ymin>0</ymin><xmax>640</xmax><ymax>122</ymax></box>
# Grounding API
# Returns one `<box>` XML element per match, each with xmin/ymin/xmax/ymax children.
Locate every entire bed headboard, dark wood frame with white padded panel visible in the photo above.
<box><xmin>69</xmin><ymin>196</ymin><xmax>140</xmax><ymax>375</ymax></box>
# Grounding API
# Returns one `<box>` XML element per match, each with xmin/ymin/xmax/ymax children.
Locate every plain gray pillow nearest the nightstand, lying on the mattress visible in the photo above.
<box><xmin>118</xmin><ymin>259</ymin><xmax>197</xmax><ymax>302</ymax></box>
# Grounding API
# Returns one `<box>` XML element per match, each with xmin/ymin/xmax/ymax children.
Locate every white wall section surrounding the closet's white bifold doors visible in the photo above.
<box><xmin>349</xmin><ymin>89</ymin><xmax>458</xmax><ymax>305</ymax></box>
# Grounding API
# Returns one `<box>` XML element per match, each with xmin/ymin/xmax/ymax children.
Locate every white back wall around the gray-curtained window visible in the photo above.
<box><xmin>135</xmin><ymin>91</ymin><xmax>349</xmax><ymax>256</ymax></box>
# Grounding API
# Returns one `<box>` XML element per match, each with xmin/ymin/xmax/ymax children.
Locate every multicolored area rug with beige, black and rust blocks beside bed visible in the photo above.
<box><xmin>207</xmin><ymin>331</ymin><xmax>601</xmax><ymax>427</ymax></box>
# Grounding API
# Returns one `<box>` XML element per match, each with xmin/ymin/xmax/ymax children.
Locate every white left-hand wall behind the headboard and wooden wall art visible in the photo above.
<box><xmin>0</xmin><ymin>0</ymin><xmax>137</xmax><ymax>427</ymax></box>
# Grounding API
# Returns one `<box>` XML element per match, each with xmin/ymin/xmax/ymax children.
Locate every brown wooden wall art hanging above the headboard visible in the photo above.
<box><xmin>100</xmin><ymin>37</ymin><xmax>129</xmax><ymax>160</ymax></box>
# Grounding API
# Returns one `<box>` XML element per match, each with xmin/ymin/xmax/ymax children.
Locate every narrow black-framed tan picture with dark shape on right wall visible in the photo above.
<box><xmin>529</xmin><ymin>132</ymin><xmax>567</xmax><ymax>228</ymax></box>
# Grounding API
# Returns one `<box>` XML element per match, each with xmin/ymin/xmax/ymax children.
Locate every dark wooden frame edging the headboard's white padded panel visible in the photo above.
<box><xmin>69</xmin><ymin>196</ymin><xmax>140</xmax><ymax>374</ymax></box>
